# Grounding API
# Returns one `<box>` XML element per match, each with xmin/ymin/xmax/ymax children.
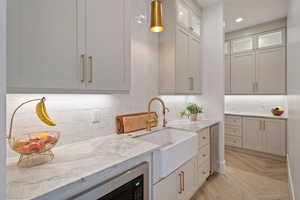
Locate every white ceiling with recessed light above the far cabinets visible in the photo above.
<box><xmin>195</xmin><ymin>0</ymin><xmax>288</xmax><ymax>32</ymax></box>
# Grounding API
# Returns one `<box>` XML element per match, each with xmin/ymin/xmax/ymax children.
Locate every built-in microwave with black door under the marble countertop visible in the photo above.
<box><xmin>71</xmin><ymin>163</ymin><xmax>149</xmax><ymax>200</ymax></box>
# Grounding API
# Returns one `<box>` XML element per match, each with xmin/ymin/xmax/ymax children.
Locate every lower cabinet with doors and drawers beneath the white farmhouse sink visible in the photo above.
<box><xmin>153</xmin><ymin>128</ymin><xmax>211</xmax><ymax>200</ymax></box>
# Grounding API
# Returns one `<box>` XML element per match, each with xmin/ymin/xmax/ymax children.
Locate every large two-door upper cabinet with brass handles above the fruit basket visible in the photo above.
<box><xmin>7</xmin><ymin>0</ymin><xmax>131</xmax><ymax>93</ymax></box>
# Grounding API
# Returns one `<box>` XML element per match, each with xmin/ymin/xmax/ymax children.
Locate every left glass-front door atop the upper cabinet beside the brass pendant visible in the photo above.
<box><xmin>177</xmin><ymin>0</ymin><xmax>190</xmax><ymax>30</ymax></box>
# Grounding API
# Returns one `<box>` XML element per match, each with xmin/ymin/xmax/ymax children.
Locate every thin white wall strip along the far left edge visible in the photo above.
<box><xmin>0</xmin><ymin>0</ymin><xmax>6</xmax><ymax>199</ymax></box>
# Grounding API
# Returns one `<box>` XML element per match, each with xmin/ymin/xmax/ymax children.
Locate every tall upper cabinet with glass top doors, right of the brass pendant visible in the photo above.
<box><xmin>159</xmin><ymin>0</ymin><xmax>202</xmax><ymax>94</ymax></box>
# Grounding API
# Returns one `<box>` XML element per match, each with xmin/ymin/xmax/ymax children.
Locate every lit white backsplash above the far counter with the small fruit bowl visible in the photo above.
<box><xmin>225</xmin><ymin>95</ymin><xmax>288</xmax><ymax>116</ymax></box>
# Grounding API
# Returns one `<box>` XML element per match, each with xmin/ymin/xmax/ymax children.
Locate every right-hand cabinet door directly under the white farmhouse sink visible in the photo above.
<box><xmin>178</xmin><ymin>159</ymin><xmax>196</xmax><ymax>200</ymax></box>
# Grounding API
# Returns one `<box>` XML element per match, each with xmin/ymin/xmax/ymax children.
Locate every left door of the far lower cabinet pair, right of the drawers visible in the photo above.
<box><xmin>243</xmin><ymin>118</ymin><xmax>264</xmax><ymax>151</ymax></box>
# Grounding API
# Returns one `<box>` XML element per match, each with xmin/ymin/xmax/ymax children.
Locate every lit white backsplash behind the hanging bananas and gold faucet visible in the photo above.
<box><xmin>7</xmin><ymin>93</ymin><xmax>208</xmax><ymax>157</ymax></box>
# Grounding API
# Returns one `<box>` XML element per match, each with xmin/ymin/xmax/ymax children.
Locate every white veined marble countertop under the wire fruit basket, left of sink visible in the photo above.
<box><xmin>7</xmin><ymin>135</ymin><xmax>159</xmax><ymax>200</ymax></box>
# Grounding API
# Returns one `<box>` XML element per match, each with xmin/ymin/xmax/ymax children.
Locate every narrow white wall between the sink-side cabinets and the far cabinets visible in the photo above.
<box><xmin>202</xmin><ymin>3</ymin><xmax>225</xmax><ymax>171</ymax></box>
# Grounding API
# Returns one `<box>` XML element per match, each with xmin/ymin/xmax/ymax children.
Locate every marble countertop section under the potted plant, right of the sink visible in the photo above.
<box><xmin>168</xmin><ymin>119</ymin><xmax>219</xmax><ymax>132</ymax></box>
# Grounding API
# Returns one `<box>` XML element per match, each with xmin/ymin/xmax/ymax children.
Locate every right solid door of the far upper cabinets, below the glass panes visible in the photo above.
<box><xmin>256</xmin><ymin>47</ymin><xmax>286</xmax><ymax>94</ymax></box>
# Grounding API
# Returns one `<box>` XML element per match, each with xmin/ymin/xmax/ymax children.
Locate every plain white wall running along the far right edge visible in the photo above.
<box><xmin>287</xmin><ymin>0</ymin><xmax>300</xmax><ymax>200</ymax></box>
